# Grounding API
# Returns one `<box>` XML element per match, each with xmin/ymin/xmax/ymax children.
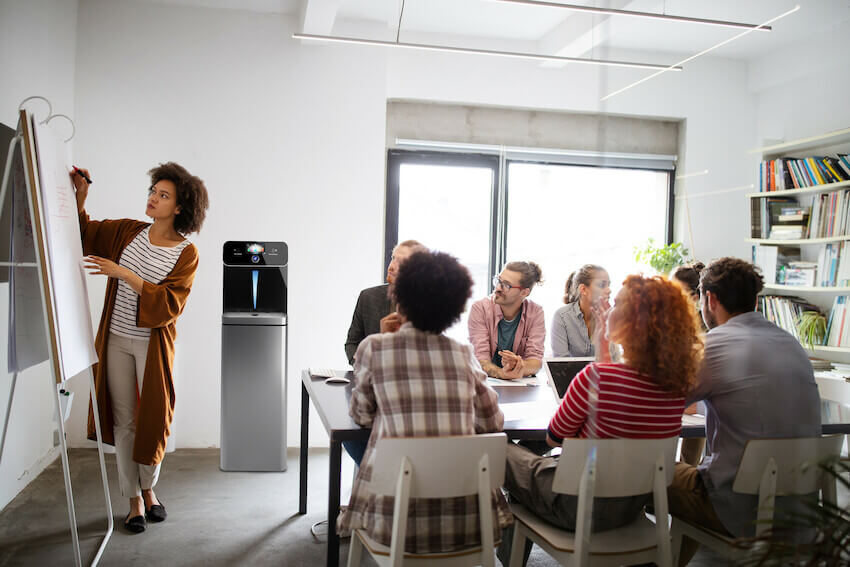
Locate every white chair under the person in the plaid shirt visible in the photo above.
<box><xmin>348</xmin><ymin>433</ymin><xmax>507</xmax><ymax>567</ymax></box>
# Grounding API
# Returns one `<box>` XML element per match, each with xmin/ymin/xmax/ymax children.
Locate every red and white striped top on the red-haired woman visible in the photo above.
<box><xmin>549</xmin><ymin>362</ymin><xmax>685</xmax><ymax>442</ymax></box>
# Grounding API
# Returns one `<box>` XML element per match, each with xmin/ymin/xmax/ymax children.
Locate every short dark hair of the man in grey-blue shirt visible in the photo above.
<box><xmin>699</xmin><ymin>257</ymin><xmax>764</xmax><ymax>315</ymax></box>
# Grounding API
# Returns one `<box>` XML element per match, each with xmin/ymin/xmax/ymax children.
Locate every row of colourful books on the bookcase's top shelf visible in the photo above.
<box><xmin>759</xmin><ymin>154</ymin><xmax>850</xmax><ymax>192</ymax></box>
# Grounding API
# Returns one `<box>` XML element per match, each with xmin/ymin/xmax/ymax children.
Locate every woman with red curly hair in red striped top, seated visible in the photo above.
<box><xmin>499</xmin><ymin>276</ymin><xmax>703</xmax><ymax>563</ymax></box>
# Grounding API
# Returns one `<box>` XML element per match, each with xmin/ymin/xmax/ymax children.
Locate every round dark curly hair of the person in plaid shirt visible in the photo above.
<box><xmin>393</xmin><ymin>251</ymin><xmax>472</xmax><ymax>333</ymax></box>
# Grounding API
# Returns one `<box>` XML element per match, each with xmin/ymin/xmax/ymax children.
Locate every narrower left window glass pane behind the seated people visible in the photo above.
<box><xmin>398</xmin><ymin>163</ymin><xmax>493</xmax><ymax>341</ymax></box>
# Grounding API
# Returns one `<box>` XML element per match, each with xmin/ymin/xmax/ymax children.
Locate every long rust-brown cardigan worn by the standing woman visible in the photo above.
<box><xmin>80</xmin><ymin>211</ymin><xmax>198</xmax><ymax>465</ymax></box>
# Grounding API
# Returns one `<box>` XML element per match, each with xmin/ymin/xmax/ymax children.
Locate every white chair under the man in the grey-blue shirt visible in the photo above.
<box><xmin>671</xmin><ymin>435</ymin><xmax>844</xmax><ymax>564</ymax></box>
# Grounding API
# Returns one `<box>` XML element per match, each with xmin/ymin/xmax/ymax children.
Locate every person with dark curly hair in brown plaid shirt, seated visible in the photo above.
<box><xmin>337</xmin><ymin>252</ymin><xmax>513</xmax><ymax>553</ymax></box>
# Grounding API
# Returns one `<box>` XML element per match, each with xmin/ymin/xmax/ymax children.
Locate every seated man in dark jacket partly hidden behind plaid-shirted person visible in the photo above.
<box><xmin>345</xmin><ymin>240</ymin><xmax>427</xmax><ymax>364</ymax></box>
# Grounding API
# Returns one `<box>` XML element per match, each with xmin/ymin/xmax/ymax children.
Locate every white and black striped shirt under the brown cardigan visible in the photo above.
<box><xmin>109</xmin><ymin>227</ymin><xmax>189</xmax><ymax>339</ymax></box>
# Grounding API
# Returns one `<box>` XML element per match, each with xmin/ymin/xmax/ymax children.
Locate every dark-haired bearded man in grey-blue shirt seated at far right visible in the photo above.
<box><xmin>668</xmin><ymin>258</ymin><xmax>821</xmax><ymax>565</ymax></box>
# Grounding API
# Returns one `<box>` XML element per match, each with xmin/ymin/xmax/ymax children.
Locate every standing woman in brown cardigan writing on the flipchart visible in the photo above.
<box><xmin>72</xmin><ymin>162</ymin><xmax>209</xmax><ymax>533</ymax></box>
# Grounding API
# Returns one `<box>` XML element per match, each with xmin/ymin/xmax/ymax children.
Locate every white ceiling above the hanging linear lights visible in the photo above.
<box><xmin>142</xmin><ymin>0</ymin><xmax>850</xmax><ymax>64</ymax></box>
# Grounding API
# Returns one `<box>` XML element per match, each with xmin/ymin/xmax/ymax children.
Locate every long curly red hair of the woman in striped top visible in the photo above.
<box><xmin>608</xmin><ymin>276</ymin><xmax>703</xmax><ymax>394</ymax></box>
